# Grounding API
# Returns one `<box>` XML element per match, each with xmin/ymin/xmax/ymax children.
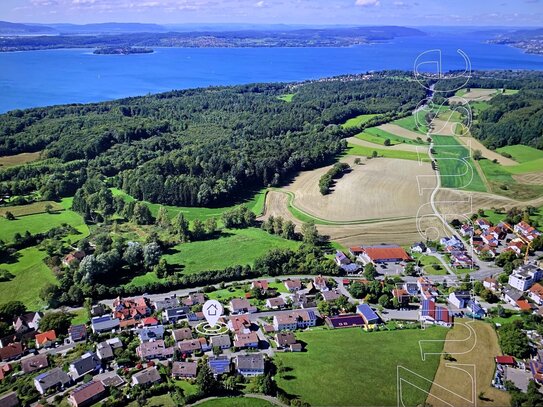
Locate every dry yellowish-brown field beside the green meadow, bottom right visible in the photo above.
<box><xmin>427</xmin><ymin>319</ymin><xmax>510</xmax><ymax>406</ymax></box>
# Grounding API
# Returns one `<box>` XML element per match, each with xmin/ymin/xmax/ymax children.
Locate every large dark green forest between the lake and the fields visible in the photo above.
<box><xmin>0</xmin><ymin>73</ymin><xmax>425</xmax><ymax>206</ymax></box>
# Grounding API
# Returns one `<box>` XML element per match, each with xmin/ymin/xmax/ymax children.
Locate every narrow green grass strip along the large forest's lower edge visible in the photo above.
<box><xmin>111</xmin><ymin>188</ymin><xmax>266</xmax><ymax>221</ymax></box>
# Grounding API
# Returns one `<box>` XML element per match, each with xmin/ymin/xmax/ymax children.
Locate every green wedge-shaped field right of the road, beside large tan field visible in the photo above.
<box><xmin>432</xmin><ymin>135</ymin><xmax>486</xmax><ymax>192</ymax></box>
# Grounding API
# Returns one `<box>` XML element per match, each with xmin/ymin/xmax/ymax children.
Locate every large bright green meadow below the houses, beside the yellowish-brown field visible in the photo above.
<box><xmin>276</xmin><ymin>327</ymin><xmax>448</xmax><ymax>406</ymax></box>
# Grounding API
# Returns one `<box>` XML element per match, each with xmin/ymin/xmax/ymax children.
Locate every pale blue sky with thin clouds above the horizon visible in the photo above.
<box><xmin>0</xmin><ymin>0</ymin><xmax>543</xmax><ymax>27</ymax></box>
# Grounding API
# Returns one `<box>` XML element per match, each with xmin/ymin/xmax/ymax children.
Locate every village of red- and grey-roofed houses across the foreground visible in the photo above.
<box><xmin>0</xmin><ymin>218</ymin><xmax>543</xmax><ymax>407</ymax></box>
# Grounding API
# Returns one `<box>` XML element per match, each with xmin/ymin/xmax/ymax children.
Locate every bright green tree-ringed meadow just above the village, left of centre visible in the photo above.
<box><xmin>164</xmin><ymin>228</ymin><xmax>300</xmax><ymax>274</ymax></box>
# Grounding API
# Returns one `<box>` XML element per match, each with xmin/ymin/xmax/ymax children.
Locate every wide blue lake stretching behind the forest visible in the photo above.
<box><xmin>0</xmin><ymin>34</ymin><xmax>543</xmax><ymax>112</ymax></box>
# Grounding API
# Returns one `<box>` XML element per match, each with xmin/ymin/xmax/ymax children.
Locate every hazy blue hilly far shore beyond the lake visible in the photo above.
<box><xmin>0</xmin><ymin>22</ymin><xmax>425</xmax><ymax>52</ymax></box>
